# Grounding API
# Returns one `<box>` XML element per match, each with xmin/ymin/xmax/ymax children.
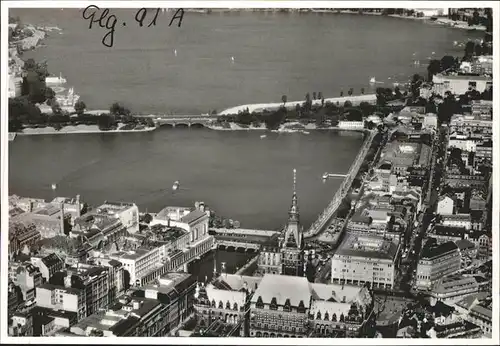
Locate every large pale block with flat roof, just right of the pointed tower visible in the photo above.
<box><xmin>331</xmin><ymin>232</ymin><xmax>400</xmax><ymax>289</ymax></box>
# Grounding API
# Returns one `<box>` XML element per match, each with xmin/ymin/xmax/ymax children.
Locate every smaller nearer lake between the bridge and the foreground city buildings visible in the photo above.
<box><xmin>9</xmin><ymin>128</ymin><xmax>363</xmax><ymax>229</ymax></box>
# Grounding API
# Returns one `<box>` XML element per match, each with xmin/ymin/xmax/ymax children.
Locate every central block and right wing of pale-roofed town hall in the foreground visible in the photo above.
<box><xmin>250</xmin><ymin>274</ymin><xmax>374</xmax><ymax>338</ymax></box>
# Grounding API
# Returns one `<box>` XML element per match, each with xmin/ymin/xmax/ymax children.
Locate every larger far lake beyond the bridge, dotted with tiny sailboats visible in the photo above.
<box><xmin>12</xmin><ymin>9</ymin><xmax>482</xmax><ymax>114</ymax></box>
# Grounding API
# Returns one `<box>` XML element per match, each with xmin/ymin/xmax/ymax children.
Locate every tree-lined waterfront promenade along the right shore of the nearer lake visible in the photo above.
<box><xmin>304</xmin><ymin>131</ymin><xmax>377</xmax><ymax>238</ymax></box>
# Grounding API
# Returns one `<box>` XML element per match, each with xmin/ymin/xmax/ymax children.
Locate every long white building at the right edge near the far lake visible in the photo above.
<box><xmin>432</xmin><ymin>74</ymin><xmax>493</xmax><ymax>97</ymax></box>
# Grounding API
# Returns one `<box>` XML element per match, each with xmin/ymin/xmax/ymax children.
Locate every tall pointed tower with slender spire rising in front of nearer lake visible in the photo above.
<box><xmin>281</xmin><ymin>169</ymin><xmax>304</xmax><ymax>276</ymax></box>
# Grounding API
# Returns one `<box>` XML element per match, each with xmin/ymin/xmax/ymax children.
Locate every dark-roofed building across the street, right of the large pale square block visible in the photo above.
<box><xmin>416</xmin><ymin>241</ymin><xmax>460</xmax><ymax>290</ymax></box>
